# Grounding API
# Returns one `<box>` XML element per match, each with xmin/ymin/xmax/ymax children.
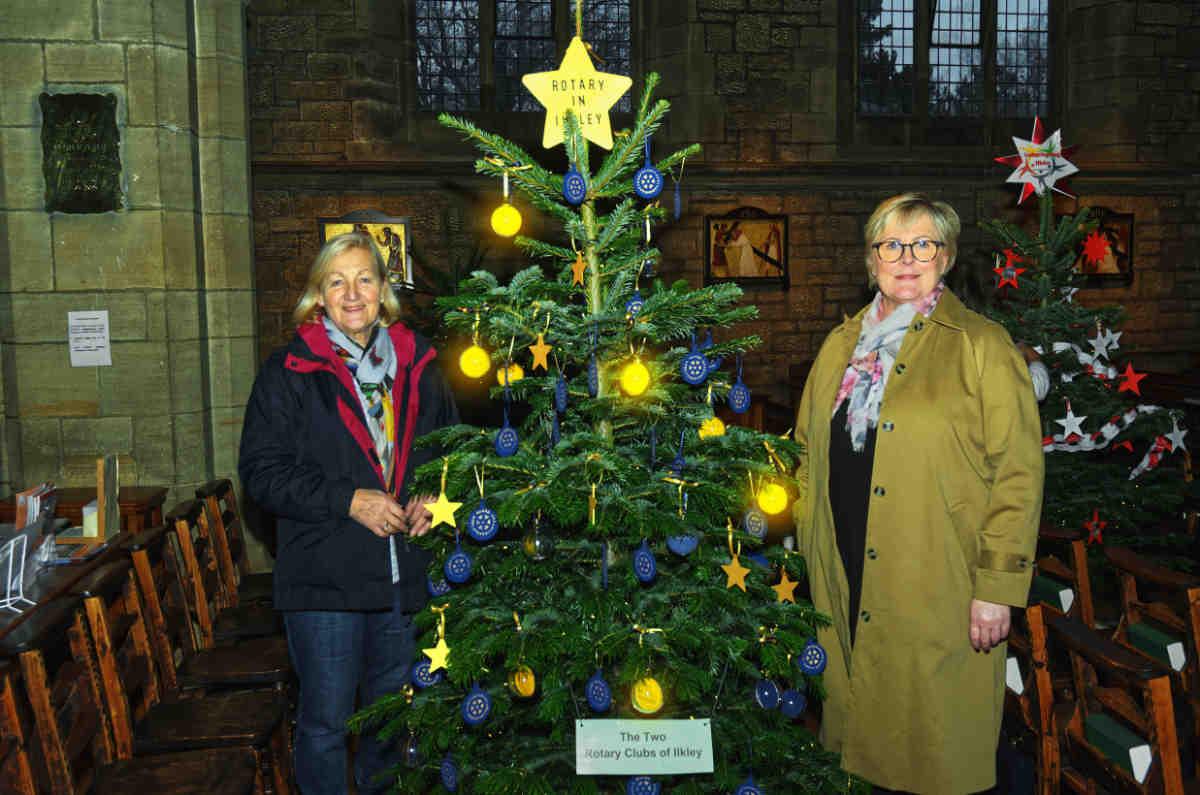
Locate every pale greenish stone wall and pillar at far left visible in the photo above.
<box><xmin>0</xmin><ymin>0</ymin><xmax>256</xmax><ymax>557</ymax></box>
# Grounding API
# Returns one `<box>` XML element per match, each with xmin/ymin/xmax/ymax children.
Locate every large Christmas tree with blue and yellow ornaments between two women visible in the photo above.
<box><xmin>354</xmin><ymin>17</ymin><xmax>854</xmax><ymax>795</ymax></box>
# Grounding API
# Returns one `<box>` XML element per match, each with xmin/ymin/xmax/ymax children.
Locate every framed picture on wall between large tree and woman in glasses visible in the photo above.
<box><xmin>704</xmin><ymin>207</ymin><xmax>787</xmax><ymax>289</ymax></box>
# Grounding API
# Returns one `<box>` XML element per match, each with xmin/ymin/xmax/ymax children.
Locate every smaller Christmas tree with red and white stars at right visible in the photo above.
<box><xmin>983</xmin><ymin>120</ymin><xmax>1188</xmax><ymax>564</ymax></box>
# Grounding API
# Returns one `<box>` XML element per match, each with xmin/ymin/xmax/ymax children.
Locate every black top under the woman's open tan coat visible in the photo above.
<box><xmin>829</xmin><ymin>400</ymin><xmax>875</xmax><ymax>645</ymax></box>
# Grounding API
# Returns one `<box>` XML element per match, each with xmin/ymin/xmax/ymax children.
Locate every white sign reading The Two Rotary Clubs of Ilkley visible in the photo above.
<box><xmin>575</xmin><ymin>718</ymin><xmax>713</xmax><ymax>776</ymax></box>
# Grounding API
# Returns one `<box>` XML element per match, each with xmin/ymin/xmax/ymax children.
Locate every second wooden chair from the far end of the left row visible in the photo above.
<box><xmin>167</xmin><ymin>500</ymin><xmax>283</xmax><ymax>648</ymax></box>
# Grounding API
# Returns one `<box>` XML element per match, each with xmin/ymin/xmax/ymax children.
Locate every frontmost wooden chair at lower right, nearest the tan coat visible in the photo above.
<box><xmin>1038</xmin><ymin>606</ymin><xmax>1184</xmax><ymax>795</ymax></box>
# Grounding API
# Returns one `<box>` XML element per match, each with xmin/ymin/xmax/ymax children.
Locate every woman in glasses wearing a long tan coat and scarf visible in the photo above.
<box><xmin>794</xmin><ymin>193</ymin><xmax>1043</xmax><ymax>795</ymax></box>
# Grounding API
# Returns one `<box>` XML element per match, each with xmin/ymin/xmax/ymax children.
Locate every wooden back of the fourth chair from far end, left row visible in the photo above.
<box><xmin>77</xmin><ymin>560</ymin><xmax>162</xmax><ymax>759</ymax></box>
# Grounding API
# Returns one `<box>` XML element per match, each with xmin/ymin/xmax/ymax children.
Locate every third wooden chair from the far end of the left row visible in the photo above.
<box><xmin>126</xmin><ymin>526</ymin><xmax>292</xmax><ymax>692</ymax></box>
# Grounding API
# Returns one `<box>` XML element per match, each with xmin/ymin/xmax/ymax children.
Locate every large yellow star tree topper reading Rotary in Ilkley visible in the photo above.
<box><xmin>521</xmin><ymin>36</ymin><xmax>634</xmax><ymax>149</ymax></box>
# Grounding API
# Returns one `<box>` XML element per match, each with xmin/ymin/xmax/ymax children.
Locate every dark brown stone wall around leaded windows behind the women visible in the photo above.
<box><xmin>248</xmin><ymin>0</ymin><xmax>1200</xmax><ymax>405</ymax></box>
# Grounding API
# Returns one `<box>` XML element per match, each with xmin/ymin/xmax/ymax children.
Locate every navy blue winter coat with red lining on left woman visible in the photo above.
<box><xmin>238</xmin><ymin>323</ymin><xmax>458</xmax><ymax>610</ymax></box>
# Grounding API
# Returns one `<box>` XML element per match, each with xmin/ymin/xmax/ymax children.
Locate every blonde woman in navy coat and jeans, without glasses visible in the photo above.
<box><xmin>239</xmin><ymin>232</ymin><xmax>458</xmax><ymax>795</ymax></box>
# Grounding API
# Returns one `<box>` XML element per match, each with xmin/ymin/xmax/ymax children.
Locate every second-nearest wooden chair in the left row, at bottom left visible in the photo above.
<box><xmin>0</xmin><ymin>598</ymin><xmax>262</xmax><ymax>795</ymax></box>
